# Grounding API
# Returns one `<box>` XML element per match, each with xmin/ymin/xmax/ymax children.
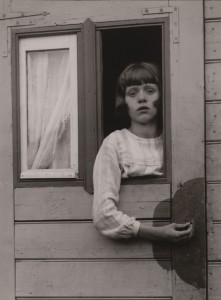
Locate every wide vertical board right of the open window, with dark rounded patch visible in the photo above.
<box><xmin>170</xmin><ymin>0</ymin><xmax>207</xmax><ymax>300</ymax></box>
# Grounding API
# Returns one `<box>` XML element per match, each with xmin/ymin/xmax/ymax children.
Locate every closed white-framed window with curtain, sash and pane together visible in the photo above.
<box><xmin>19</xmin><ymin>34</ymin><xmax>78</xmax><ymax>179</ymax></box>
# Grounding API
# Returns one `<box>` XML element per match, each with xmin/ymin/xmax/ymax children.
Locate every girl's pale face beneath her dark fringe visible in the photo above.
<box><xmin>125</xmin><ymin>83</ymin><xmax>160</xmax><ymax>125</ymax></box>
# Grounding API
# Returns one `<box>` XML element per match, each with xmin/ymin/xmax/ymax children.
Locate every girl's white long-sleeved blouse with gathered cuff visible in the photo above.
<box><xmin>93</xmin><ymin>129</ymin><xmax>163</xmax><ymax>239</ymax></box>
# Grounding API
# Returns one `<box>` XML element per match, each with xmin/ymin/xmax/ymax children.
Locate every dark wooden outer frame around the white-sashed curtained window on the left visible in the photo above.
<box><xmin>11</xmin><ymin>24</ymin><xmax>85</xmax><ymax>187</ymax></box>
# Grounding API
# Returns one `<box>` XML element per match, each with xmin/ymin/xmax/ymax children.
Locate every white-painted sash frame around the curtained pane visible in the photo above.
<box><xmin>19</xmin><ymin>34</ymin><xmax>78</xmax><ymax>179</ymax></box>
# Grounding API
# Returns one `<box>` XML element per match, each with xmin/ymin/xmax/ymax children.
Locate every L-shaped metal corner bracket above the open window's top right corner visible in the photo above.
<box><xmin>142</xmin><ymin>6</ymin><xmax>179</xmax><ymax>43</ymax></box>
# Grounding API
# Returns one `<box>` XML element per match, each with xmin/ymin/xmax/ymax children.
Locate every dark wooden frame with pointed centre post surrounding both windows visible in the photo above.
<box><xmin>12</xmin><ymin>17</ymin><xmax>171</xmax><ymax>193</ymax></box>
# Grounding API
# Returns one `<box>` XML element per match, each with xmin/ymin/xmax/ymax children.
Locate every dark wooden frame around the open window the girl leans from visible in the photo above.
<box><xmin>94</xmin><ymin>17</ymin><xmax>172</xmax><ymax>185</ymax></box>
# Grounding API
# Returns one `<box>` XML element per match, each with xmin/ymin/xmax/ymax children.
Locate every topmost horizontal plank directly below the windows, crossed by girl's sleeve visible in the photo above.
<box><xmin>15</xmin><ymin>184</ymin><xmax>170</xmax><ymax>221</ymax></box>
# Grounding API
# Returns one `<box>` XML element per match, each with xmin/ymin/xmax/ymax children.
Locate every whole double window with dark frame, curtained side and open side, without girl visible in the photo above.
<box><xmin>12</xmin><ymin>17</ymin><xmax>170</xmax><ymax>193</ymax></box>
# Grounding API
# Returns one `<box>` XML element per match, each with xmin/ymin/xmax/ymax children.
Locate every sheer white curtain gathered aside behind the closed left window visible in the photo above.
<box><xmin>27</xmin><ymin>50</ymin><xmax>71</xmax><ymax>169</ymax></box>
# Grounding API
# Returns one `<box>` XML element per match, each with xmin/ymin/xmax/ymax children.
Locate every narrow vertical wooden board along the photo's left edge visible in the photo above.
<box><xmin>0</xmin><ymin>22</ymin><xmax>15</xmax><ymax>300</ymax></box>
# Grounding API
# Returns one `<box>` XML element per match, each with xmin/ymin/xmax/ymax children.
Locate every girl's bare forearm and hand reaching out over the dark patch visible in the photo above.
<box><xmin>138</xmin><ymin>222</ymin><xmax>194</xmax><ymax>243</ymax></box>
